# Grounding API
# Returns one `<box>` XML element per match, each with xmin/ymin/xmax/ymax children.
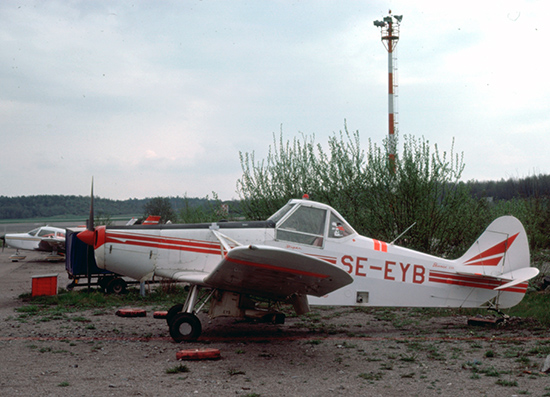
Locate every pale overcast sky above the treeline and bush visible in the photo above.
<box><xmin>0</xmin><ymin>0</ymin><xmax>550</xmax><ymax>199</ymax></box>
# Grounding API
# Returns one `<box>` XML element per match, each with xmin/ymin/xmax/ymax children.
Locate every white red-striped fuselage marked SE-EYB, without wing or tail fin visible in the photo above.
<box><xmin>91</xmin><ymin>198</ymin><xmax>527</xmax><ymax>307</ymax></box>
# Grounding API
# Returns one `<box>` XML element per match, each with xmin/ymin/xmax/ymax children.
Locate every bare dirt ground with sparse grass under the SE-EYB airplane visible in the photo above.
<box><xmin>0</xmin><ymin>249</ymin><xmax>550</xmax><ymax>396</ymax></box>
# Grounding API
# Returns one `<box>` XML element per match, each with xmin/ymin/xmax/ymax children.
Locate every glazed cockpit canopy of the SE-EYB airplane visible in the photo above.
<box><xmin>269</xmin><ymin>200</ymin><xmax>356</xmax><ymax>247</ymax></box>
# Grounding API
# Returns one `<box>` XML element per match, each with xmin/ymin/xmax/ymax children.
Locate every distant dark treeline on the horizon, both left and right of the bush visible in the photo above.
<box><xmin>0</xmin><ymin>175</ymin><xmax>550</xmax><ymax>219</ymax></box>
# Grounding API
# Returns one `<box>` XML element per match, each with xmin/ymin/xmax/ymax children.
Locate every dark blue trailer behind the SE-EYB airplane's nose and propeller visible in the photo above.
<box><xmin>65</xmin><ymin>228</ymin><xmax>130</xmax><ymax>294</ymax></box>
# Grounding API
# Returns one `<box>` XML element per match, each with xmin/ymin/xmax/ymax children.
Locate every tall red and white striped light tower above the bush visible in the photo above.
<box><xmin>374</xmin><ymin>10</ymin><xmax>403</xmax><ymax>169</ymax></box>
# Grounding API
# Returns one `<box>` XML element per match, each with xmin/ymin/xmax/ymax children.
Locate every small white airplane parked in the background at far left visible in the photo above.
<box><xmin>2</xmin><ymin>226</ymin><xmax>65</xmax><ymax>261</ymax></box>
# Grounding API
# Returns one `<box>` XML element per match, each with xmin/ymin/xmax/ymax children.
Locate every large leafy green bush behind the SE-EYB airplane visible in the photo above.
<box><xmin>237</xmin><ymin>127</ymin><xmax>490</xmax><ymax>256</ymax></box>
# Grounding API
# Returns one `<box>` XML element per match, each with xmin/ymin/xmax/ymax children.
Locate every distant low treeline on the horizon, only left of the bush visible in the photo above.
<box><xmin>0</xmin><ymin>195</ymin><xmax>226</xmax><ymax>219</ymax></box>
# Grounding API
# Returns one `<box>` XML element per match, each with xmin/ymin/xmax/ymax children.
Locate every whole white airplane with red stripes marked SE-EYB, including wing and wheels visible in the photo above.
<box><xmin>78</xmin><ymin>189</ymin><xmax>539</xmax><ymax>342</ymax></box>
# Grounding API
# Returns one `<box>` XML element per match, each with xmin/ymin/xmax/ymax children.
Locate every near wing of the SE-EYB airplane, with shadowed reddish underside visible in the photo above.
<box><xmin>204</xmin><ymin>245</ymin><xmax>353</xmax><ymax>300</ymax></box>
